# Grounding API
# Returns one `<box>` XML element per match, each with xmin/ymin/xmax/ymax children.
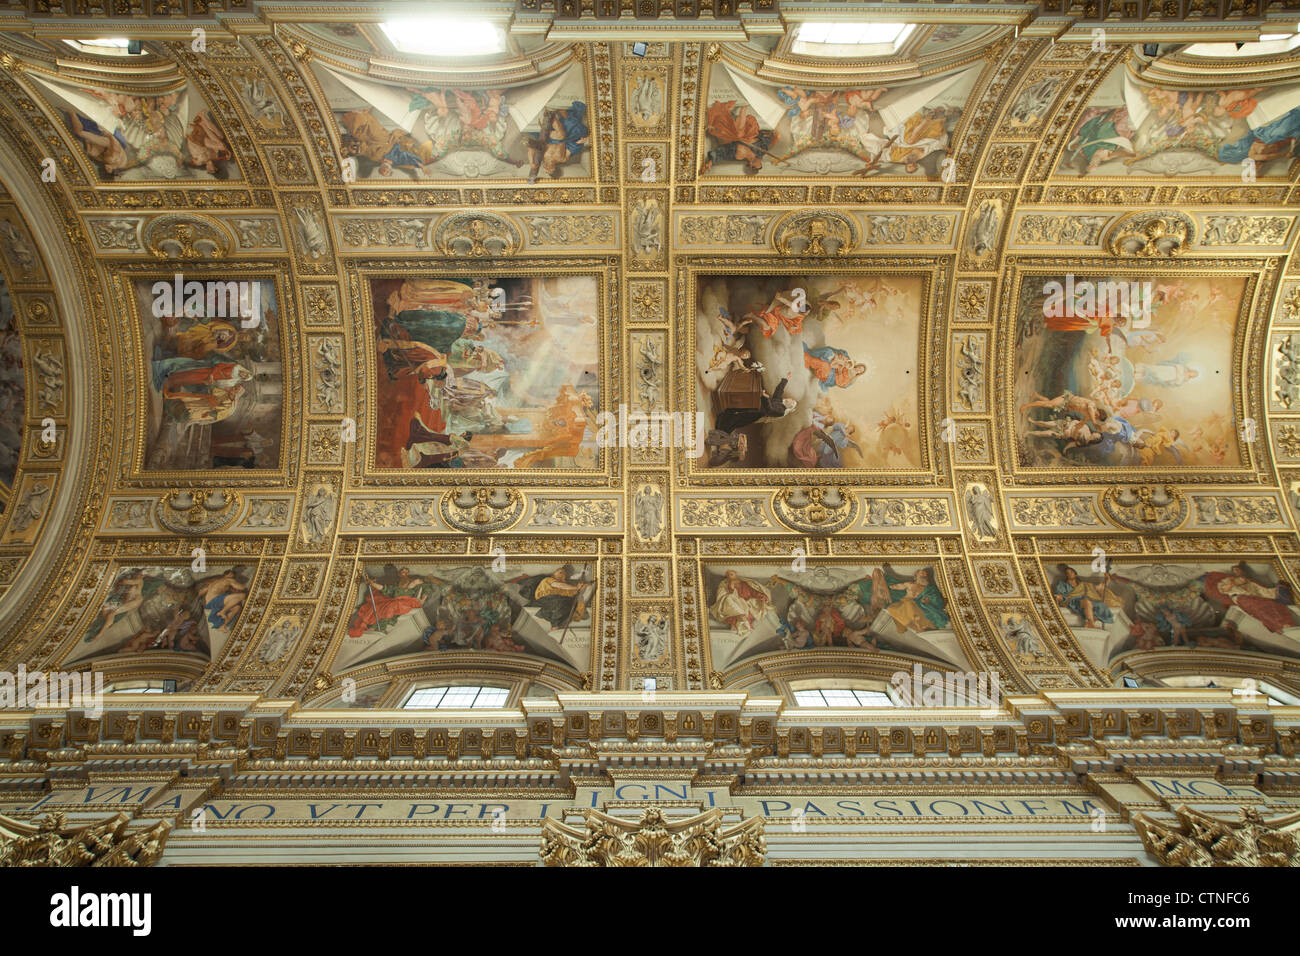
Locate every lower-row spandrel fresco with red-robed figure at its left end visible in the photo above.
<box><xmin>333</xmin><ymin>563</ymin><xmax>595</xmax><ymax>671</ymax></box>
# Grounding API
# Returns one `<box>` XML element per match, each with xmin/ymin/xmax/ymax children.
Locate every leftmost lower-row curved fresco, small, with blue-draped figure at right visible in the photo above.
<box><xmin>68</xmin><ymin>564</ymin><xmax>254</xmax><ymax>663</ymax></box>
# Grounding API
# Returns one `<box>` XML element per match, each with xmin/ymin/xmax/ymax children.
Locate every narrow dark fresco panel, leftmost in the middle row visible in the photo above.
<box><xmin>135</xmin><ymin>278</ymin><xmax>283</xmax><ymax>471</ymax></box>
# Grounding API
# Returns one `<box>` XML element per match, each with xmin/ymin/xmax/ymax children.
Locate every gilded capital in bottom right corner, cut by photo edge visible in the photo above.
<box><xmin>1134</xmin><ymin>806</ymin><xmax>1300</xmax><ymax>866</ymax></box>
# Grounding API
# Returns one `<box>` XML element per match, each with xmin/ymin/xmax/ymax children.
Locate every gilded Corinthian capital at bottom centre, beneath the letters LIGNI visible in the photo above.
<box><xmin>541</xmin><ymin>806</ymin><xmax>767</xmax><ymax>866</ymax></box>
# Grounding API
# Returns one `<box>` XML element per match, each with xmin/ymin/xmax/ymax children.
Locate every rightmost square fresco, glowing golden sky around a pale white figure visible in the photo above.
<box><xmin>1014</xmin><ymin>276</ymin><xmax>1247</xmax><ymax>467</ymax></box>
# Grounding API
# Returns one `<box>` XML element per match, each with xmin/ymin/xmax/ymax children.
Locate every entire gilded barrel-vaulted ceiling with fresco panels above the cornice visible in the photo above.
<box><xmin>0</xmin><ymin>3</ymin><xmax>1300</xmax><ymax>706</ymax></box>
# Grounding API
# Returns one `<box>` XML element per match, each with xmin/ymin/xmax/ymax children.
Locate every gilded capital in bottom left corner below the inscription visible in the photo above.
<box><xmin>0</xmin><ymin>813</ymin><xmax>172</xmax><ymax>866</ymax></box>
